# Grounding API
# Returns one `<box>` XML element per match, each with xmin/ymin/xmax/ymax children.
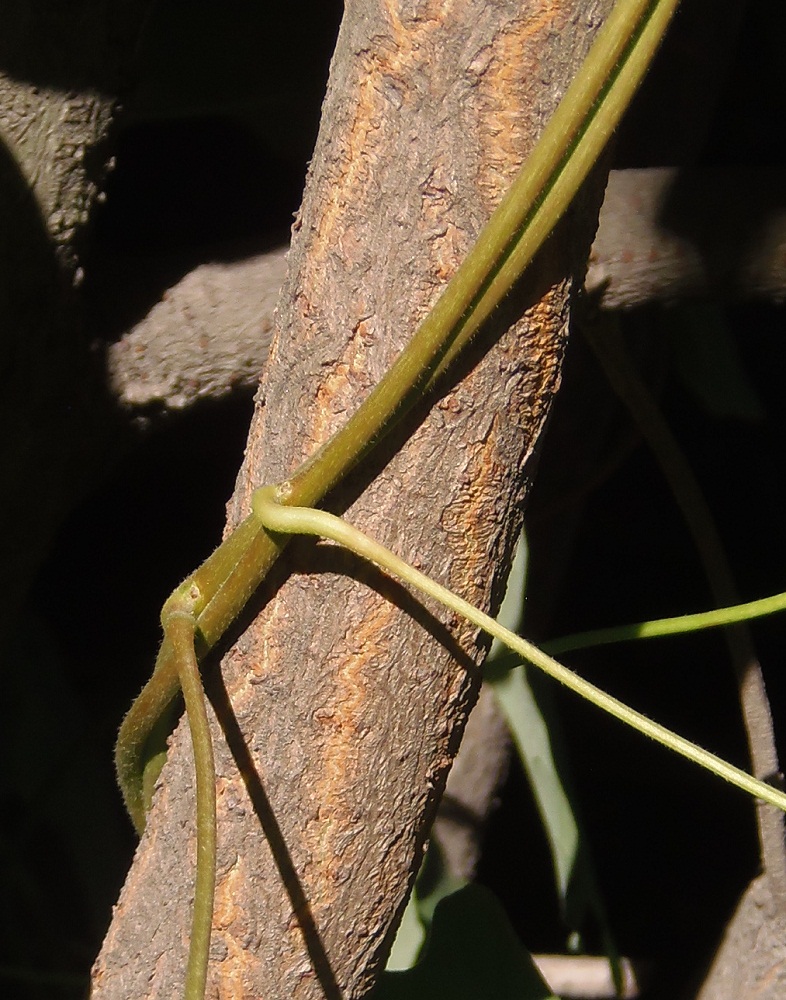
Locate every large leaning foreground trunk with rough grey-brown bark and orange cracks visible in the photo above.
<box><xmin>93</xmin><ymin>0</ymin><xmax>611</xmax><ymax>1000</ymax></box>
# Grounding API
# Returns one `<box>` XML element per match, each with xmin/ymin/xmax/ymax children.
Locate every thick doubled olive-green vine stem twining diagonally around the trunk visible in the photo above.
<box><xmin>115</xmin><ymin>0</ymin><xmax>678</xmax><ymax>833</ymax></box>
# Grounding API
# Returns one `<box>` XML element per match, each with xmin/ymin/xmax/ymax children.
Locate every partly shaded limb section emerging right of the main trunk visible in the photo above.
<box><xmin>587</xmin><ymin>167</ymin><xmax>786</xmax><ymax>309</ymax></box>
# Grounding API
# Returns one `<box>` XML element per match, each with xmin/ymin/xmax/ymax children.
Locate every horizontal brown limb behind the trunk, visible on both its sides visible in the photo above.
<box><xmin>107</xmin><ymin>167</ymin><xmax>786</xmax><ymax>409</ymax></box>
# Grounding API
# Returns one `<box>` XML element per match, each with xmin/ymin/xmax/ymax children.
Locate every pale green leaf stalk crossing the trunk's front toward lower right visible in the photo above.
<box><xmin>252</xmin><ymin>483</ymin><xmax>786</xmax><ymax>812</ymax></box>
